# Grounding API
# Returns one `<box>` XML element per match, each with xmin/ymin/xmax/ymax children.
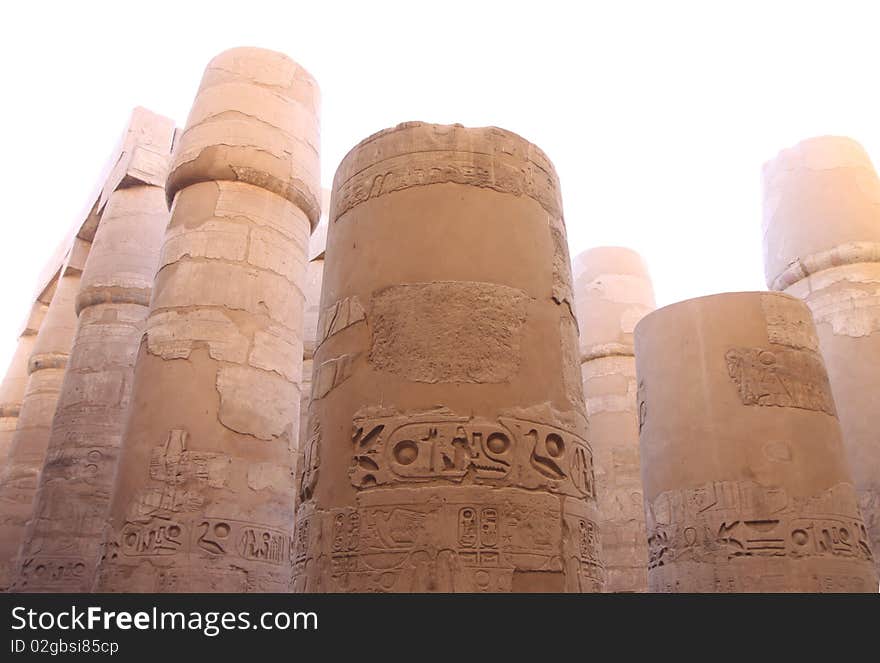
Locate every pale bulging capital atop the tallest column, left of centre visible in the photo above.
<box><xmin>167</xmin><ymin>48</ymin><xmax>320</xmax><ymax>227</ymax></box>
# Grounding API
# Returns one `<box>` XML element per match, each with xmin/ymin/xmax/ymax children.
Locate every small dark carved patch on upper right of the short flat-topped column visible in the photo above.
<box><xmin>725</xmin><ymin>348</ymin><xmax>837</xmax><ymax>416</ymax></box>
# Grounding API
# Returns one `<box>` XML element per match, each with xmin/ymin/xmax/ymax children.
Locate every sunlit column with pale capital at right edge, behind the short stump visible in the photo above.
<box><xmin>764</xmin><ymin>136</ymin><xmax>880</xmax><ymax>580</ymax></box>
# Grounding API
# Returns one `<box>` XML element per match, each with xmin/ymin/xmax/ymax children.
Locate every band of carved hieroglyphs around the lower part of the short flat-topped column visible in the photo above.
<box><xmin>647</xmin><ymin>481</ymin><xmax>873</xmax><ymax>569</ymax></box>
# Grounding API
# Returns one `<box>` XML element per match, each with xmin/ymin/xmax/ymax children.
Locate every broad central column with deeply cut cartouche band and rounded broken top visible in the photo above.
<box><xmin>294</xmin><ymin>122</ymin><xmax>602</xmax><ymax>592</ymax></box>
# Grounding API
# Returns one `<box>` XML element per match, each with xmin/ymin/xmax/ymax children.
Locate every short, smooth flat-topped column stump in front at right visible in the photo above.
<box><xmin>635</xmin><ymin>292</ymin><xmax>877</xmax><ymax>592</ymax></box>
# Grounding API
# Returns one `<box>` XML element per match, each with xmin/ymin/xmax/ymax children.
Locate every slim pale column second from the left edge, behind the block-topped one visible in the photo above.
<box><xmin>0</xmin><ymin>245</ymin><xmax>88</xmax><ymax>590</ymax></box>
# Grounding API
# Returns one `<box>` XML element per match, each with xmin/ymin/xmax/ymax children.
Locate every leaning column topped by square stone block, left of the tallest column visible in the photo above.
<box><xmin>14</xmin><ymin>109</ymin><xmax>174</xmax><ymax>592</ymax></box>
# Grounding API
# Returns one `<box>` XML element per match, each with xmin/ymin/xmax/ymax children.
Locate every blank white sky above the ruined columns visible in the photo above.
<box><xmin>0</xmin><ymin>0</ymin><xmax>880</xmax><ymax>371</ymax></box>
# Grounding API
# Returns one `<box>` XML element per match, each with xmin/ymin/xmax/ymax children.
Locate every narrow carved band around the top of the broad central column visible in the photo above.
<box><xmin>332</xmin><ymin>150</ymin><xmax>562</xmax><ymax>221</ymax></box>
